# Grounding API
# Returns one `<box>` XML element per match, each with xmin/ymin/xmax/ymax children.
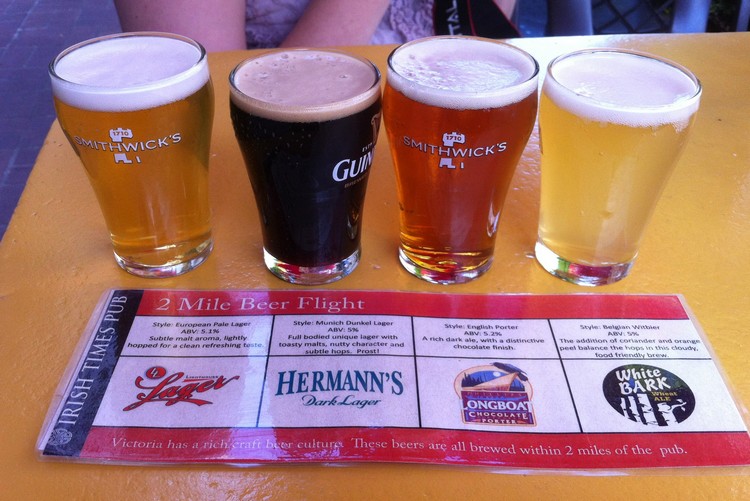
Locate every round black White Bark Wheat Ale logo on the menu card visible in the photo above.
<box><xmin>602</xmin><ymin>364</ymin><xmax>695</xmax><ymax>426</ymax></box>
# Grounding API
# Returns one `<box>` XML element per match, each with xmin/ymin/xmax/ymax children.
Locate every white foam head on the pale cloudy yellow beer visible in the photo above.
<box><xmin>544</xmin><ymin>49</ymin><xmax>701</xmax><ymax>127</ymax></box>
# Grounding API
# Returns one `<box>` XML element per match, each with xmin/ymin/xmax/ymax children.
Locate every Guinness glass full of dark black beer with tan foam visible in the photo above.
<box><xmin>229</xmin><ymin>49</ymin><xmax>380</xmax><ymax>285</ymax></box>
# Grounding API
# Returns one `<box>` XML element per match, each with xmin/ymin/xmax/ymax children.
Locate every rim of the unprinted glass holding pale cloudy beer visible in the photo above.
<box><xmin>545</xmin><ymin>47</ymin><xmax>703</xmax><ymax>113</ymax></box>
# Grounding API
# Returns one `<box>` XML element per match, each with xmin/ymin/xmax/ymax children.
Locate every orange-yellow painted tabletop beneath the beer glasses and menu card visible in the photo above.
<box><xmin>0</xmin><ymin>33</ymin><xmax>750</xmax><ymax>500</ymax></box>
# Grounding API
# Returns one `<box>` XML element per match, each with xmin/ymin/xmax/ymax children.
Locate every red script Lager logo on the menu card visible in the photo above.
<box><xmin>122</xmin><ymin>366</ymin><xmax>240</xmax><ymax>411</ymax></box>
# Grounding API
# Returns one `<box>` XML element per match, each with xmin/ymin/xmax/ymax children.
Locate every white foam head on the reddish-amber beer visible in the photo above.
<box><xmin>388</xmin><ymin>36</ymin><xmax>539</xmax><ymax>109</ymax></box>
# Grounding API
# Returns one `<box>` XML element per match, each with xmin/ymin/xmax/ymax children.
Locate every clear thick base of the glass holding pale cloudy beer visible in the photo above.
<box><xmin>534</xmin><ymin>241</ymin><xmax>633</xmax><ymax>287</ymax></box>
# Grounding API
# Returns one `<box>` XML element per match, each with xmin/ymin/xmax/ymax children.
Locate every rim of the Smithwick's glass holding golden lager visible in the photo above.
<box><xmin>48</xmin><ymin>31</ymin><xmax>209</xmax><ymax>109</ymax></box>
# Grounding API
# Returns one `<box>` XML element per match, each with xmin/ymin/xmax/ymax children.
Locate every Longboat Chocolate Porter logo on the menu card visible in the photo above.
<box><xmin>454</xmin><ymin>362</ymin><xmax>536</xmax><ymax>426</ymax></box>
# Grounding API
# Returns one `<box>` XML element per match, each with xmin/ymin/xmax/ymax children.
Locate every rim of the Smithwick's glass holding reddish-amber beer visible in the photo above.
<box><xmin>387</xmin><ymin>35</ymin><xmax>540</xmax><ymax>108</ymax></box>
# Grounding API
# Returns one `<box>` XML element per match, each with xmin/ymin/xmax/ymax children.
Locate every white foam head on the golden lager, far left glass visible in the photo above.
<box><xmin>50</xmin><ymin>33</ymin><xmax>209</xmax><ymax>111</ymax></box>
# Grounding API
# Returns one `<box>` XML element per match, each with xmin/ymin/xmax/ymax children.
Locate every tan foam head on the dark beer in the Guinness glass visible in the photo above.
<box><xmin>229</xmin><ymin>49</ymin><xmax>380</xmax><ymax>122</ymax></box>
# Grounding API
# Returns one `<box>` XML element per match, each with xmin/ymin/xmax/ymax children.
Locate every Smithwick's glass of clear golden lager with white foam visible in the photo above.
<box><xmin>50</xmin><ymin>33</ymin><xmax>213</xmax><ymax>277</ymax></box>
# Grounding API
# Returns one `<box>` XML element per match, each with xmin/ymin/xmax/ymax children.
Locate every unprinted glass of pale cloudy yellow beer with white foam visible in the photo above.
<box><xmin>536</xmin><ymin>49</ymin><xmax>701</xmax><ymax>285</ymax></box>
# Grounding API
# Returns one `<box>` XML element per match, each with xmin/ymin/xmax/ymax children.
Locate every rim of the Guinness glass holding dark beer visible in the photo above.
<box><xmin>229</xmin><ymin>47</ymin><xmax>381</xmax><ymax>121</ymax></box>
